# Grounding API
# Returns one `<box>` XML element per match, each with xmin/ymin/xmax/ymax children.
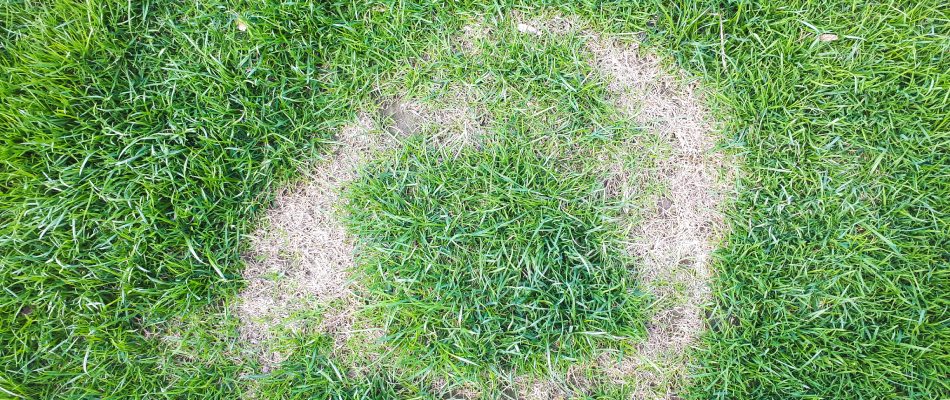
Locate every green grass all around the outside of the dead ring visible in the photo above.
<box><xmin>0</xmin><ymin>0</ymin><xmax>950</xmax><ymax>399</ymax></box>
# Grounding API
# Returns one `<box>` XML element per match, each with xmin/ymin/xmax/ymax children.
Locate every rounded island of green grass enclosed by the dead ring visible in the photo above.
<box><xmin>346</xmin><ymin>138</ymin><xmax>643</xmax><ymax>378</ymax></box>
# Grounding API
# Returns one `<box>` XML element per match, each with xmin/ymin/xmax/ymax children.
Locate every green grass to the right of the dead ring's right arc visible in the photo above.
<box><xmin>661</xmin><ymin>2</ymin><xmax>950</xmax><ymax>398</ymax></box>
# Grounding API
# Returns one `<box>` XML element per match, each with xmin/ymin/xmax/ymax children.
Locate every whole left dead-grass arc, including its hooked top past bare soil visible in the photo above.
<box><xmin>235</xmin><ymin>86</ymin><xmax>487</xmax><ymax>370</ymax></box>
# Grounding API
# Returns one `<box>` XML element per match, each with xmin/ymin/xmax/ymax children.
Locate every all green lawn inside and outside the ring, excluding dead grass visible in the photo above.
<box><xmin>0</xmin><ymin>0</ymin><xmax>950</xmax><ymax>399</ymax></box>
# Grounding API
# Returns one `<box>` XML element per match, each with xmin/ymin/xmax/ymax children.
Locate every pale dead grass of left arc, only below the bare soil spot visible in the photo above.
<box><xmin>236</xmin><ymin>113</ymin><xmax>396</xmax><ymax>366</ymax></box>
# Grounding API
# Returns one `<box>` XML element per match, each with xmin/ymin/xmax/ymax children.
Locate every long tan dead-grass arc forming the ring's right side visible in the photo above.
<box><xmin>586</xmin><ymin>26</ymin><xmax>730</xmax><ymax>398</ymax></box>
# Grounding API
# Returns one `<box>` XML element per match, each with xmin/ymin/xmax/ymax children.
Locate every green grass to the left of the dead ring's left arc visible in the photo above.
<box><xmin>0</xmin><ymin>1</ymin><xmax>426</xmax><ymax>398</ymax></box>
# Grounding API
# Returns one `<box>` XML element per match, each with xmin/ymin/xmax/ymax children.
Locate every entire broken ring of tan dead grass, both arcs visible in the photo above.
<box><xmin>237</xmin><ymin>10</ymin><xmax>735</xmax><ymax>398</ymax></box>
